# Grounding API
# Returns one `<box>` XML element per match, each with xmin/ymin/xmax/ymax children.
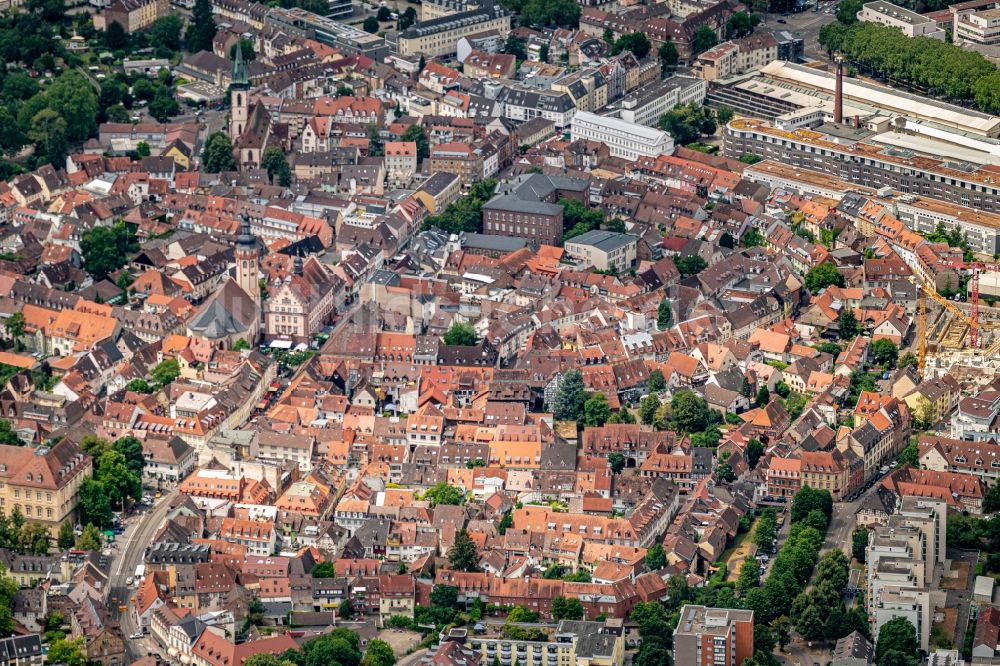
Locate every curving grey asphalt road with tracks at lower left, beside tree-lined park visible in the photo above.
<box><xmin>109</xmin><ymin>490</ymin><xmax>177</xmax><ymax>662</ymax></box>
